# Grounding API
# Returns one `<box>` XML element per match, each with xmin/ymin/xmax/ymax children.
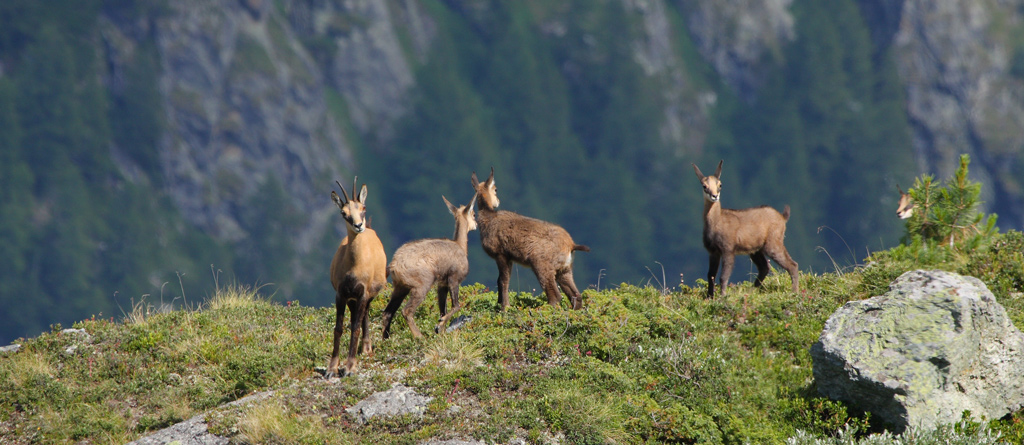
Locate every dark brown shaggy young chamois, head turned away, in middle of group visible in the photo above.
<box><xmin>470</xmin><ymin>168</ymin><xmax>590</xmax><ymax>311</ymax></box>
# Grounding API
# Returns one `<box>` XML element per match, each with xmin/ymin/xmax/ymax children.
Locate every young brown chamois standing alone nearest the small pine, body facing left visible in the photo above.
<box><xmin>693</xmin><ymin>162</ymin><xmax>800</xmax><ymax>298</ymax></box>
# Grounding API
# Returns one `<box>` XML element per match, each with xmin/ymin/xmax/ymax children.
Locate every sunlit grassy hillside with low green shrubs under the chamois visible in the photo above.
<box><xmin>0</xmin><ymin>232</ymin><xmax>1024</xmax><ymax>444</ymax></box>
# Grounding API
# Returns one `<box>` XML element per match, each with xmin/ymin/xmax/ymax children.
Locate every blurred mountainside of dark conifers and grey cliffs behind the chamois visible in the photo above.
<box><xmin>0</xmin><ymin>0</ymin><xmax>1024</xmax><ymax>344</ymax></box>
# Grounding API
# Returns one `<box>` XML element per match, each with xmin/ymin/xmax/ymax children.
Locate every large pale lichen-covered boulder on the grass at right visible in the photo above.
<box><xmin>811</xmin><ymin>270</ymin><xmax>1024</xmax><ymax>431</ymax></box>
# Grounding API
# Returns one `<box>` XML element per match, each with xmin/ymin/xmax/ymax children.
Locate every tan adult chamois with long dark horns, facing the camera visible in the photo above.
<box><xmin>324</xmin><ymin>178</ymin><xmax>387</xmax><ymax>379</ymax></box>
